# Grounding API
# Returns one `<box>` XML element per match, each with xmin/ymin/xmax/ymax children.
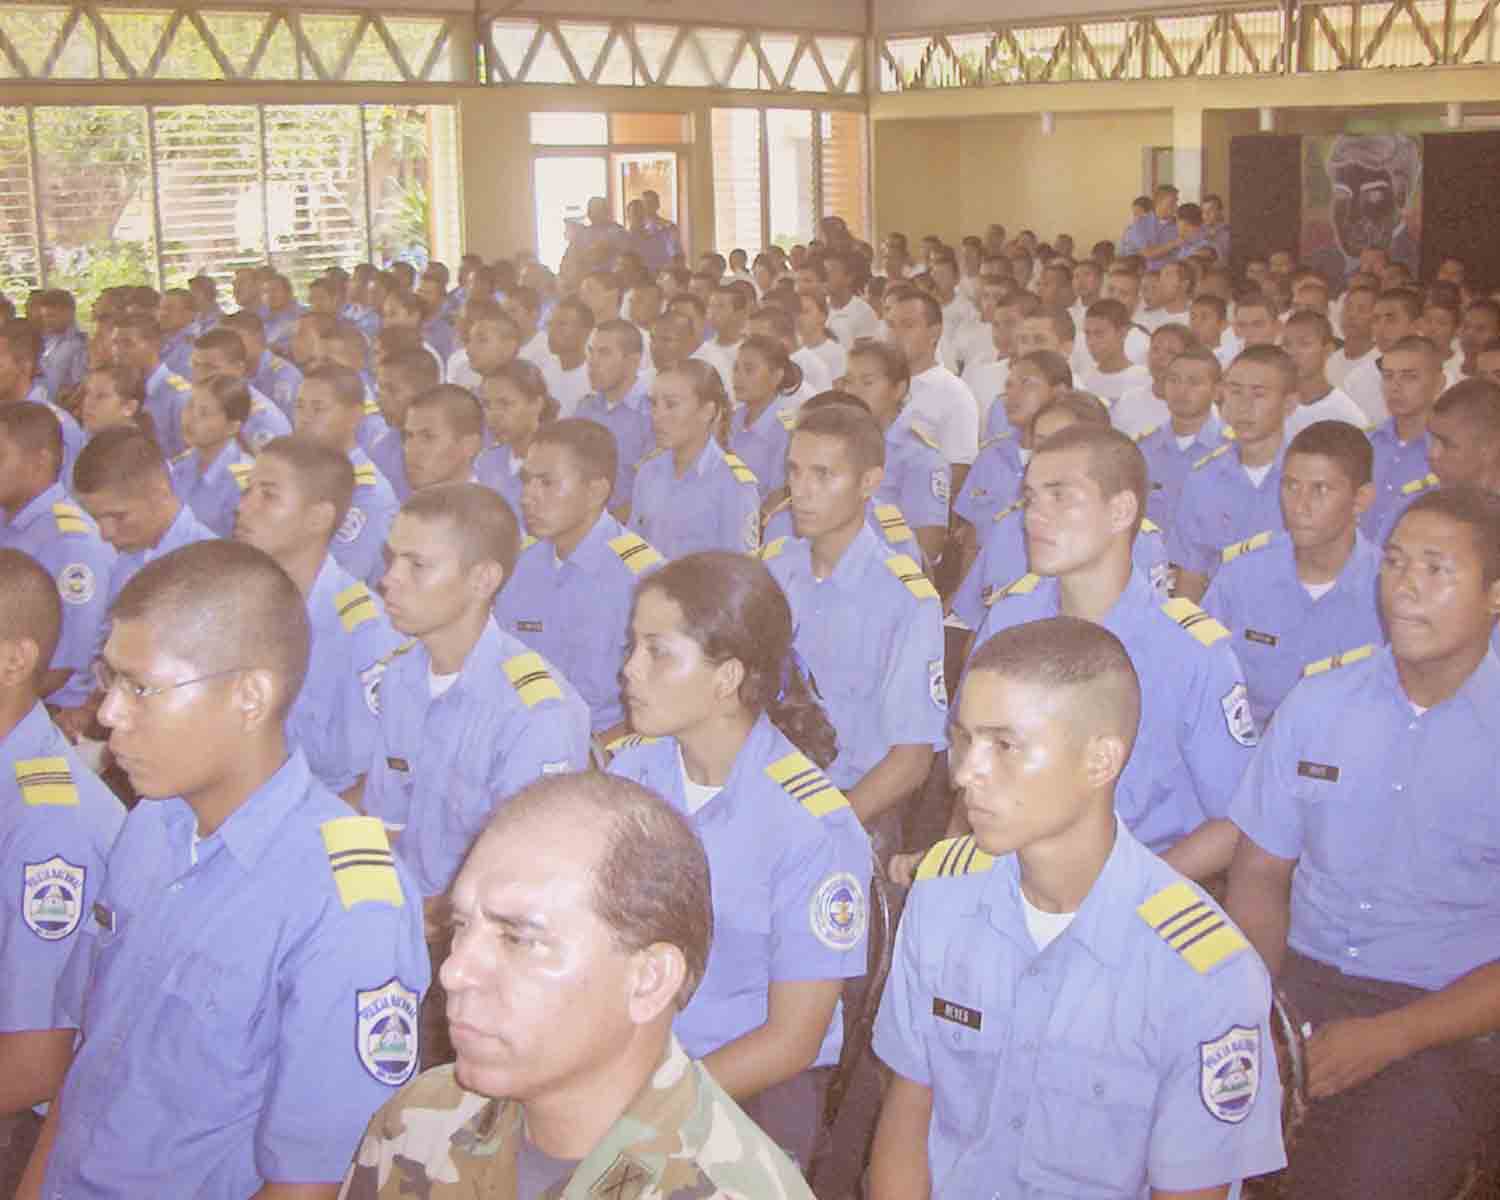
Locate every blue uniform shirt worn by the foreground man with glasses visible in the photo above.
<box><xmin>42</xmin><ymin>752</ymin><xmax>431</xmax><ymax>1200</ymax></box>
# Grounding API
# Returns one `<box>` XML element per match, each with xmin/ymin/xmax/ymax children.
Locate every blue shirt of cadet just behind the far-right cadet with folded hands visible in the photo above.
<box><xmin>1203</xmin><ymin>534</ymin><xmax>1385</xmax><ymax>729</ymax></box>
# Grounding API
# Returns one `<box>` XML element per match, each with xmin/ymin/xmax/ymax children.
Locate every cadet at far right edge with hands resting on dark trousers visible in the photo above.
<box><xmin>1226</xmin><ymin>488</ymin><xmax>1500</xmax><ymax>1200</ymax></box>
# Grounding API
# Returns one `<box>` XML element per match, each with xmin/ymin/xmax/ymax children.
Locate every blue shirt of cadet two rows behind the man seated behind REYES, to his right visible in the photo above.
<box><xmin>1167</xmin><ymin>441</ymin><xmax>1286</xmax><ymax>579</ymax></box>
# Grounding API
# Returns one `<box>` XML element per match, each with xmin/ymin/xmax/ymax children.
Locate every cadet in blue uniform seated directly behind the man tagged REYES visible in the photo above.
<box><xmin>950</xmin><ymin>425</ymin><xmax>1256</xmax><ymax>879</ymax></box>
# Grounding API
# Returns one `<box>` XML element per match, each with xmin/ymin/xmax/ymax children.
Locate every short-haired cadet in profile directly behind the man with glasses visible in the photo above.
<box><xmin>234</xmin><ymin>437</ymin><xmax>404</xmax><ymax>807</ymax></box>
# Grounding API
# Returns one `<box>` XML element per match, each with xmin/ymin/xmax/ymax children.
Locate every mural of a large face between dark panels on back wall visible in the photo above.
<box><xmin>1302</xmin><ymin>134</ymin><xmax>1422</xmax><ymax>284</ymax></box>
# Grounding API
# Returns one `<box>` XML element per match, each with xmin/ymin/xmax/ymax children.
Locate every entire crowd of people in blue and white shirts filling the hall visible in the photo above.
<box><xmin>0</xmin><ymin>180</ymin><xmax>1500</xmax><ymax>1200</ymax></box>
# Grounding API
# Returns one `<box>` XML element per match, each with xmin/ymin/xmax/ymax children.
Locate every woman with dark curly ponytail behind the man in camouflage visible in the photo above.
<box><xmin>609</xmin><ymin>552</ymin><xmax>872</xmax><ymax>1167</ymax></box>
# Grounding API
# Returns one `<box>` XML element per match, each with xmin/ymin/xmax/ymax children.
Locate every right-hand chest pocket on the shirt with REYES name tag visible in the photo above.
<box><xmin>1020</xmin><ymin>1047</ymin><xmax>1158</xmax><ymax>1200</ymax></box>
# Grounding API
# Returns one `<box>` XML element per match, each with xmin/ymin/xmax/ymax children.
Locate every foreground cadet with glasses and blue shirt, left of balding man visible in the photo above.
<box><xmin>23</xmin><ymin>540</ymin><xmax>428</xmax><ymax>1200</ymax></box>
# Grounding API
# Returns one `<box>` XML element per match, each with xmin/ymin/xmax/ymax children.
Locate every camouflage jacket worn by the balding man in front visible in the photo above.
<box><xmin>339</xmin><ymin>1038</ymin><xmax>813</xmax><ymax>1200</ymax></box>
